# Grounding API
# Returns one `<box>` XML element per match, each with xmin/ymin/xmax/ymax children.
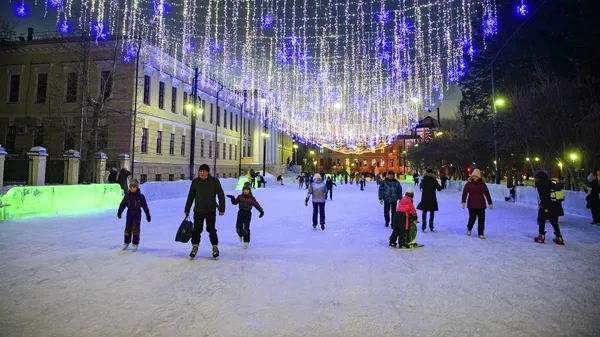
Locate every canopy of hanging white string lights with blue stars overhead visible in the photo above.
<box><xmin>15</xmin><ymin>0</ymin><xmax>500</xmax><ymax>153</ymax></box>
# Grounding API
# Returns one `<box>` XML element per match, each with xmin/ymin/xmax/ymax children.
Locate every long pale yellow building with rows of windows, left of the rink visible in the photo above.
<box><xmin>0</xmin><ymin>32</ymin><xmax>293</xmax><ymax>182</ymax></box>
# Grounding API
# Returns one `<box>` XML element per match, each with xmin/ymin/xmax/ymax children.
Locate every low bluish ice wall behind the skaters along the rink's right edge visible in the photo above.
<box><xmin>447</xmin><ymin>180</ymin><xmax>590</xmax><ymax>216</ymax></box>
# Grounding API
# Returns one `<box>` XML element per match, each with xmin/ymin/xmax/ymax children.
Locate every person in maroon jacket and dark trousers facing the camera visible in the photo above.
<box><xmin>462</xmin><ymin>169</ymin><xmax>494</xmax><ymax>239</ymax></box>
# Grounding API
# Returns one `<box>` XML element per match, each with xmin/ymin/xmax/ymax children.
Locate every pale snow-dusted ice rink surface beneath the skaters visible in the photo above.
<box><xmin>0</xmin><ymin>183</ymin><xmax>600</xmax><ymax>337</ymax></box>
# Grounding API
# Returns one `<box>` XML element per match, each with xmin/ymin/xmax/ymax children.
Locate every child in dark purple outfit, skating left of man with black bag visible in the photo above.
<box><xmin>117</xmin><ymin>179</ymin><xmax>150</xmax><ymax>252</ymax></box>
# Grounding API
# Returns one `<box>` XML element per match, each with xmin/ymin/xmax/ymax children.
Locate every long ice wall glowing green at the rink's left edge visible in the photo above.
<box><xmin>0</xmin><ymin>184</ymin><xmax>123</xmax><ymax>220</ymax></box>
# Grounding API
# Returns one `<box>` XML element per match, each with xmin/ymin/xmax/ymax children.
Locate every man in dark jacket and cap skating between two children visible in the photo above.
<box><xmin>185</xmin><ymin>164</ymin><xmax>225</xmax><ymax>259</ymax></box>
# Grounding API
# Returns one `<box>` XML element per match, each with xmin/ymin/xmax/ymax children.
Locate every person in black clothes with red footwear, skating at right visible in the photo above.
<box><xmin>533</xmin><ymin>171</ymin><xmax>565</xmax><ymax>245</ymax></box>
